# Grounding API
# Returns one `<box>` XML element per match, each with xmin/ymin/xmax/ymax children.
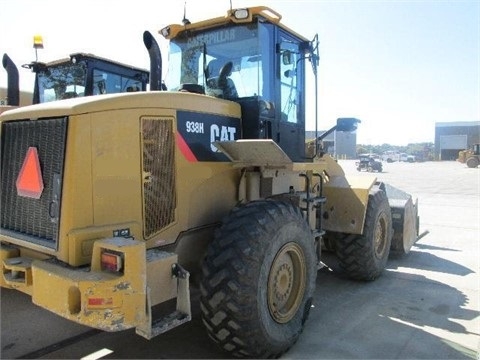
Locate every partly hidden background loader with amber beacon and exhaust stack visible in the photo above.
<box><xmin>0</xmin><ymin>36</ymin><xmax>149</xmax><ymax>114</ymax></box>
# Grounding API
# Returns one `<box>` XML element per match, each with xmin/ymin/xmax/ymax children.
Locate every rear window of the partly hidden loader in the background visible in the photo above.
<box><xmin>37</xmin><ymin>63</ymin><xmax>87</xmax><ymax>103</ymax></box>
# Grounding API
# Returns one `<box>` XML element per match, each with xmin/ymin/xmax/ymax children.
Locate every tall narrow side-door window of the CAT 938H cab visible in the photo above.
<box><xmin>280</xmin><ymin>39</ymin><xmax>299</xmax><ymax>123</ymax></box>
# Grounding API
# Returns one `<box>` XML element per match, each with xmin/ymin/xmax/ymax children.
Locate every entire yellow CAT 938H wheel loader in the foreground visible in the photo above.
<box><xmin>0</xmin><ymin>7</ymin><xmax>418</xmax><ymax>357</ymax></box>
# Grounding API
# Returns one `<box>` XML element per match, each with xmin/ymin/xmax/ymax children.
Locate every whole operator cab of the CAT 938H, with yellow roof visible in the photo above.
<box><xmin>161</xmin><ymin>7</ymin><xmax>313</xmax><ymax>162</ymax></box>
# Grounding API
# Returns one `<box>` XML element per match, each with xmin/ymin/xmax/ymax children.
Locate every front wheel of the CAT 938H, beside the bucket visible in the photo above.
<box><xmin>335</xmin><ymin>188</ymin><xmax>393</xmax><ymax>280</ymax></box>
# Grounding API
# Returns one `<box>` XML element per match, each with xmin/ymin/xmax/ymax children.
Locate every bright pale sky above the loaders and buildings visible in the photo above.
<box><xmin>0</xmin><ymin>0</ymin><xmax>480</xmax><ymax>145</ymax></box>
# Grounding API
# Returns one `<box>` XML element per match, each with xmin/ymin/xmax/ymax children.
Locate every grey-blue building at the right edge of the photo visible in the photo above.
<box><xmin>435</xmin><ymin>121</ymin><xmax>480</xmax><ymax>160</ymax></box>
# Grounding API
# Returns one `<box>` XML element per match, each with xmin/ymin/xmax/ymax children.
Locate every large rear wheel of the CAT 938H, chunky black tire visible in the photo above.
<box><xmin>200</xmin><ymin>200</ymin><xmax>317</xmax><ymax>358</ymax></box>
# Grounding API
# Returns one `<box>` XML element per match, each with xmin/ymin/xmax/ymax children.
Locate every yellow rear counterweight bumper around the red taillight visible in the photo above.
<box><xmin>32</xmin><ymin>238</ymin><xmax>146</xmax><ymax>331</ymax></box>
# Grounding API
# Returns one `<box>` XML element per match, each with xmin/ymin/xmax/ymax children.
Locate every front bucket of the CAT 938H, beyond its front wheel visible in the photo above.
<box><xmin>383</xmin><ymin>184</ymin><xmax>420</xmax><ymax>255</ymax></box>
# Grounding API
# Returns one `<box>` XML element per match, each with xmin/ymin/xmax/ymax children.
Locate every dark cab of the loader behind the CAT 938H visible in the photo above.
<box><xmin>24</xmin><ymin>53</ymin><xmax>149</xmax><ymax>104</ymax></box>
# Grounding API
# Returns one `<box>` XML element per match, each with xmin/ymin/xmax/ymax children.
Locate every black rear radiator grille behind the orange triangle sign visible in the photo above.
<box><xmin>0</xmin><ymin>118</ymin><xmax>67</xmax><ymax>249</ymax></box>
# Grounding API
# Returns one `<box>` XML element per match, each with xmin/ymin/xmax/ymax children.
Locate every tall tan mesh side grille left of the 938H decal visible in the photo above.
<box><xmin>142</xmin><ymin>118</ymin><xmax>176</xmax><ymax>238</ymax></box>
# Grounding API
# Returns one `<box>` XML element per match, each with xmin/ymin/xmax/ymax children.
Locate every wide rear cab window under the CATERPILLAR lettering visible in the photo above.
<box><xmin>165</xmin><ymin>24</ymin><xmax>262</xmax><ymax>98</ymax></box>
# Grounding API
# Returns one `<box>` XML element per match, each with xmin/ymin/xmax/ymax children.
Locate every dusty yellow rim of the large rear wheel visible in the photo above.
<box><xmin>268</xmin><ymin>243</ymin><xmax>307</xmax><ymax>323</ymax></box>
